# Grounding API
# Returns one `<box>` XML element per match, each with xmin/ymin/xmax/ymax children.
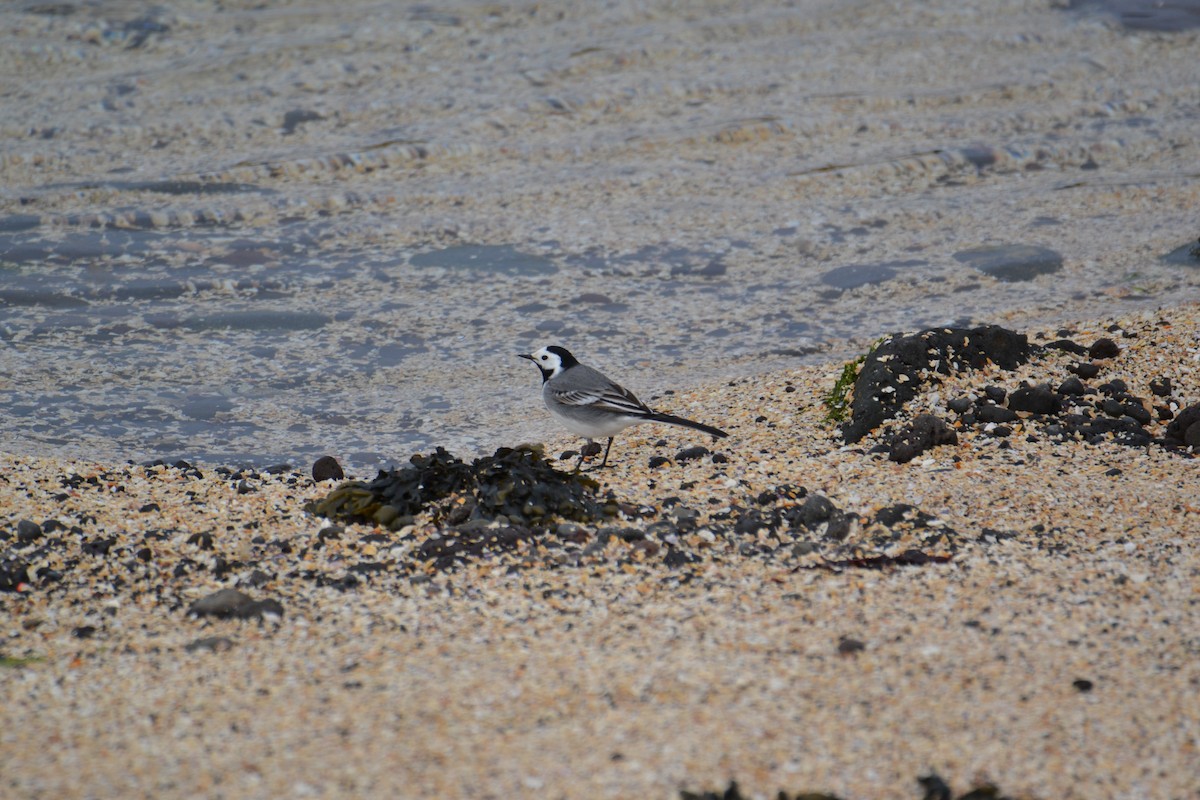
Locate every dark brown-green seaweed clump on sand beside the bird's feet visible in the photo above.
<box><xmin>307</xmin><ymin>445</ymin><xmax>616</xmax><ymax>530</ymax></box>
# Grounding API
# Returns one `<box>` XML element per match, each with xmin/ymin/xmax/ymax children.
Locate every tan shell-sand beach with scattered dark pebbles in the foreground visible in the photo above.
<box><xmin>0</xmin><ymin>305</ymin><xmax>1200</xmax><ymax>798</ymax></box>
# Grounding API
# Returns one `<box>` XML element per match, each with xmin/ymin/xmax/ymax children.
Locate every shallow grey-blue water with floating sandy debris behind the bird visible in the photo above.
<box><xmin>0</xmin><ymin>1</ymin><xmax>1200</xmax><ymax>467</ymax></box>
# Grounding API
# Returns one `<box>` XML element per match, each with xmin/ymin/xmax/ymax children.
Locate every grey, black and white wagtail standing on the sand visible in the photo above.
<box><xmin>517</xmin><ymin>344</ymin><xmax>730</xmax><ymax>469</ymax></box>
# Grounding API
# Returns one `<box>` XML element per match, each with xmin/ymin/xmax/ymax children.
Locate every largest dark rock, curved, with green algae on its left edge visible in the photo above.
<box><xmin>841</xmin><ymin>325</ymin><xmax>1031</xmax><ymax>443</ymax></box>
